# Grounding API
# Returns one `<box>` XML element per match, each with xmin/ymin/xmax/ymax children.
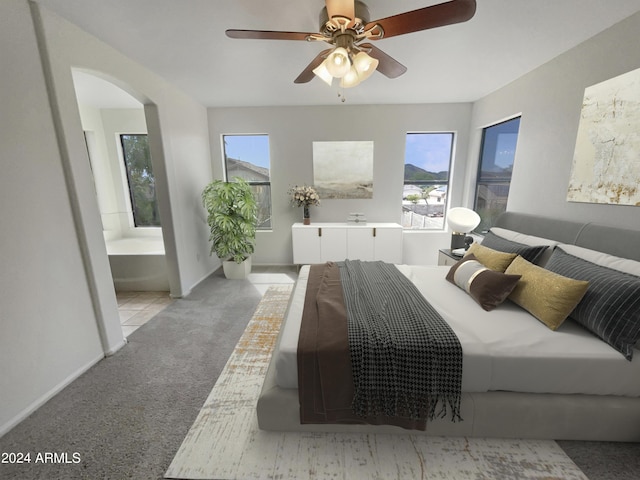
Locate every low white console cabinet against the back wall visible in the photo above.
<box><xmin>291</xmin><ymin>223</ymin><xmax>402</xmax><ymax>265</ymax></box>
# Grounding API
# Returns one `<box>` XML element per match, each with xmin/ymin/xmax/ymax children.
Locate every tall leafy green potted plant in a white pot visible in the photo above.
<box><xmin>202</xmin><ymin>177</ymin><xmax>258</xmax><ymax>279</ymax></box>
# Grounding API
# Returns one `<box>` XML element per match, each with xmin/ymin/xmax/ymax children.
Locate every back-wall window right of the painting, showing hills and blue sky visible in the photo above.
<box><xmin>402</xmin><ymin>132</ymin><xmax>453</xmax><ymax>230</ymax></box>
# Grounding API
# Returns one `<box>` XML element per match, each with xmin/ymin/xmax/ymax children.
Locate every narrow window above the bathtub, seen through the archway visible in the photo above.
<box><xmin>120</xmin><ymin>134</ymin><xmax>160</xmax><ymax>227</ymax></box>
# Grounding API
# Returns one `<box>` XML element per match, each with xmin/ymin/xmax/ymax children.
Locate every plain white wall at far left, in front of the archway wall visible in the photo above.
<box><xmin>0</xmin><ymin>0</ymin><xmax>104</xmax><ymax>435</ymax></box>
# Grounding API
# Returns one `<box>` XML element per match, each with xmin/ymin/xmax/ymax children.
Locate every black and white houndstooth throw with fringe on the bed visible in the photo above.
<box><xmin>337</xmin><ymin>260</ymin><xmax>462</xmax><ymax>421</ymax></box>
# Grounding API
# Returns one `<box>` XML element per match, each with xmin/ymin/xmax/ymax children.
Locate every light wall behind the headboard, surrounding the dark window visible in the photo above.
<box><xmin>467</xmin><ymin>10</ymin><xmax>640</xmax><ymax>228</ymax></box>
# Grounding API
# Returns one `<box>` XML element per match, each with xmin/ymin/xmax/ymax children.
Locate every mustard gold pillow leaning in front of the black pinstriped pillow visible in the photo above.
<box><xmin>505</xmin><ymin>256</ymin><xmax>589</xmax><ymax>330</ymax></box>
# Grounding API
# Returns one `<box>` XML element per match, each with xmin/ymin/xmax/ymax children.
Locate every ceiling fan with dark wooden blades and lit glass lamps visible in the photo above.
<box><xmin>226</xmin><ymin>0</ymin><xmax>476</xmax><ymax>87</ymax></box>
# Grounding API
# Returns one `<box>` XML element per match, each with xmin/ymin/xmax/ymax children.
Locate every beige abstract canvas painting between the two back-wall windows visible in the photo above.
<box><xmin>313</xmin><ymin>141</ymin><xmax>373</xmax><ymax>200</ymax></box>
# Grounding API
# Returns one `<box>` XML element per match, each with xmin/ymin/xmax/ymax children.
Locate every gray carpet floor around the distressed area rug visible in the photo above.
<box><xmin>0</xmin><ymin>266</ymin><xmax>640</xmax><ymax>480</ymax></box>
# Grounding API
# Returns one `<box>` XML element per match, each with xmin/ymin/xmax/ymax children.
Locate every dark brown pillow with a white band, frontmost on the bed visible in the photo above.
<box><xmin>447</xmin><ymin>254</ymin><xmax>520</xmax><ymax>312</ymax></box>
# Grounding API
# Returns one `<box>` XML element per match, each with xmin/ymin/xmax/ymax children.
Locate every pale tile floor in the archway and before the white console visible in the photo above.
<box><xmin>116</xmin><ymin>265</ymin><xmax>298</xmax><ymax>337</ymax></box>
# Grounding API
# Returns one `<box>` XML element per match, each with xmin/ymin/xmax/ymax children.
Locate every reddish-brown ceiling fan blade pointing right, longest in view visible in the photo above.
<box><xmin>365</xmin><ymin>0</ymin><xmax>476</xmax><ymax>40</ymax></box>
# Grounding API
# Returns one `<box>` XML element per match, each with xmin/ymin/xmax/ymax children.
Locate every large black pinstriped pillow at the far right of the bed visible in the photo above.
<box><xmin>546</xmin><ymin>247</ymin><xmax>640</xmax><ymax>361</ymax></box>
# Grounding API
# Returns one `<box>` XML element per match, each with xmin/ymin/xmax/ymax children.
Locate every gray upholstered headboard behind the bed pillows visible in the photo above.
<box><xmin>495</xmin><ymin>212</ymin><xmax>640</xmax><ymax>261</ymax></box>
